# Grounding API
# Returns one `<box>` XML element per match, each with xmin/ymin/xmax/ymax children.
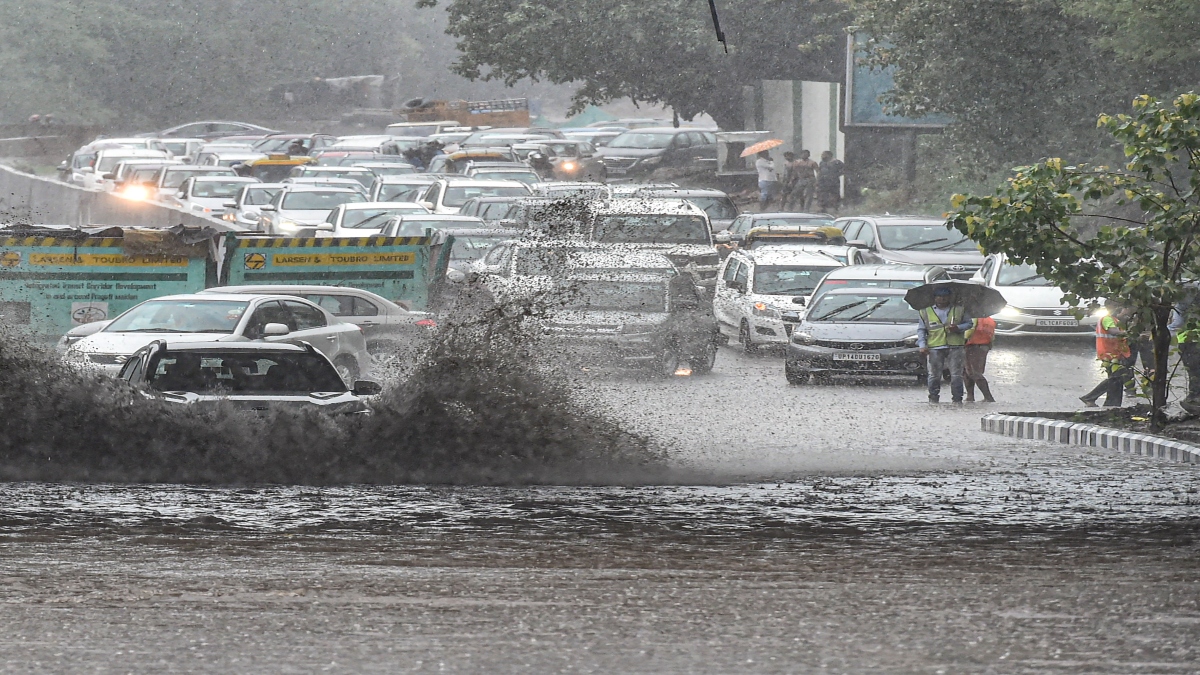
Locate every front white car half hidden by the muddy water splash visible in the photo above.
<box><xmin>118</xmin><ymin>340</ymin><xmax>382</xmax><ymax>414</ymax></box>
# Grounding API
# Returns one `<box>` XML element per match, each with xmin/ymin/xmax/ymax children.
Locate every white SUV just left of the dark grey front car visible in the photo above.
<box><xmin>713</xmin><ymin>247</ymin><xmax>845</xmax><ymax>353</ymax></box>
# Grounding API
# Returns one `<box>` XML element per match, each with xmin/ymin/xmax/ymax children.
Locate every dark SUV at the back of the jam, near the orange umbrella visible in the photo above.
<box><xmin>596</xmin><ymin>126</ymin><xmax>716</xmax><ymax>178</ymax></box>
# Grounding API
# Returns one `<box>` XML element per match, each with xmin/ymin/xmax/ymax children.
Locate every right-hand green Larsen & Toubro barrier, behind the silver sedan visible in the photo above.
<box><xmin>221</xmin><ymin>234</ymin><xmax>448</xmax><ymax>309</ymax></box>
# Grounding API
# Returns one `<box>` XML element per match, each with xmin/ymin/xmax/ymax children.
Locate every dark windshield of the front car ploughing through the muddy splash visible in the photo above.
<box><xmin>148</xmin><ymin>351</ymin><xmax>347</xmax><ymax>394</ymax></box>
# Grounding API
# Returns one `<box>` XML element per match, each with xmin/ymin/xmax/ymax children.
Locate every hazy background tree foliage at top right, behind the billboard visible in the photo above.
<box><xmin>854</xmin><ymin>0</ymin><xmax>1200</xmax><ymax>169</ymax></box>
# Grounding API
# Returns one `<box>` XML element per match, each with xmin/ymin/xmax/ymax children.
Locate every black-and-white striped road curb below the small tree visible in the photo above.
<box><xmin>979</xmin><ymin>414</ymin><xmax>1200</xmax><ymax>464</ymax></box>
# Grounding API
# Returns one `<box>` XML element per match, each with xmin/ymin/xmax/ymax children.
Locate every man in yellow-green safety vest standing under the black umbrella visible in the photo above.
<box><xmin>917</xmin><ymin>286</ymin><xmax>972</xmax><ymax>404</ymax></box>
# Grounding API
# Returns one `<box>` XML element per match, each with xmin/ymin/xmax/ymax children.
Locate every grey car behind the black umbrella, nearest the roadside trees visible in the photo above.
<box><xmin>836</xmin><ymin>216</ymin><xmax>983</xmax><ymax>280</ymax></box>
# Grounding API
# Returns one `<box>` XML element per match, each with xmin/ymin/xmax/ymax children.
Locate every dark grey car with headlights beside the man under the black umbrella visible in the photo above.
<box><xmin>784</xmin><ymin>288</ymin><xmax>926</xmax><ymax>384</ymax></box>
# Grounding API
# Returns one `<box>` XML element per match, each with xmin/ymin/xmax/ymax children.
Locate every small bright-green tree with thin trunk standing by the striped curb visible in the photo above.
<box><xmin>949</xmin><ymin>94</ymin><xmax>1200</xmax><ymax>429</ymax></box>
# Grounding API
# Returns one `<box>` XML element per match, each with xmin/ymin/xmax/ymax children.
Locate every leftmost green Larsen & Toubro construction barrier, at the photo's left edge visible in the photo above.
<box><xmin>0</xmin><ymin>233</ymin><xmax>208</xmax><ymax>342</ymax></box>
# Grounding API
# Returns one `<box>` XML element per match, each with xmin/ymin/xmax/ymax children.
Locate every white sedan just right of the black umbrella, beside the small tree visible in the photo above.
<box><xmin>971</xmin><ymin>253</ymin><xmax>1104</xmax><ymax>338</ymax></box>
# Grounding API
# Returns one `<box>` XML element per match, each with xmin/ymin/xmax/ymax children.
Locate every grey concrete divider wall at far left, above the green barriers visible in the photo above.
<box><xmin>0</xmin><ymin>166</ymin><xmax>219</xmax><ymax>227</ymax></box>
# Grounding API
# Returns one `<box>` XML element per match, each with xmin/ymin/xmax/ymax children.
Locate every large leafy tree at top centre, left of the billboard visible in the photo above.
<box><xmin>420</xmin><ymin>0</ymin><xmax>850</xmax><ymax>129</ymax></box>
